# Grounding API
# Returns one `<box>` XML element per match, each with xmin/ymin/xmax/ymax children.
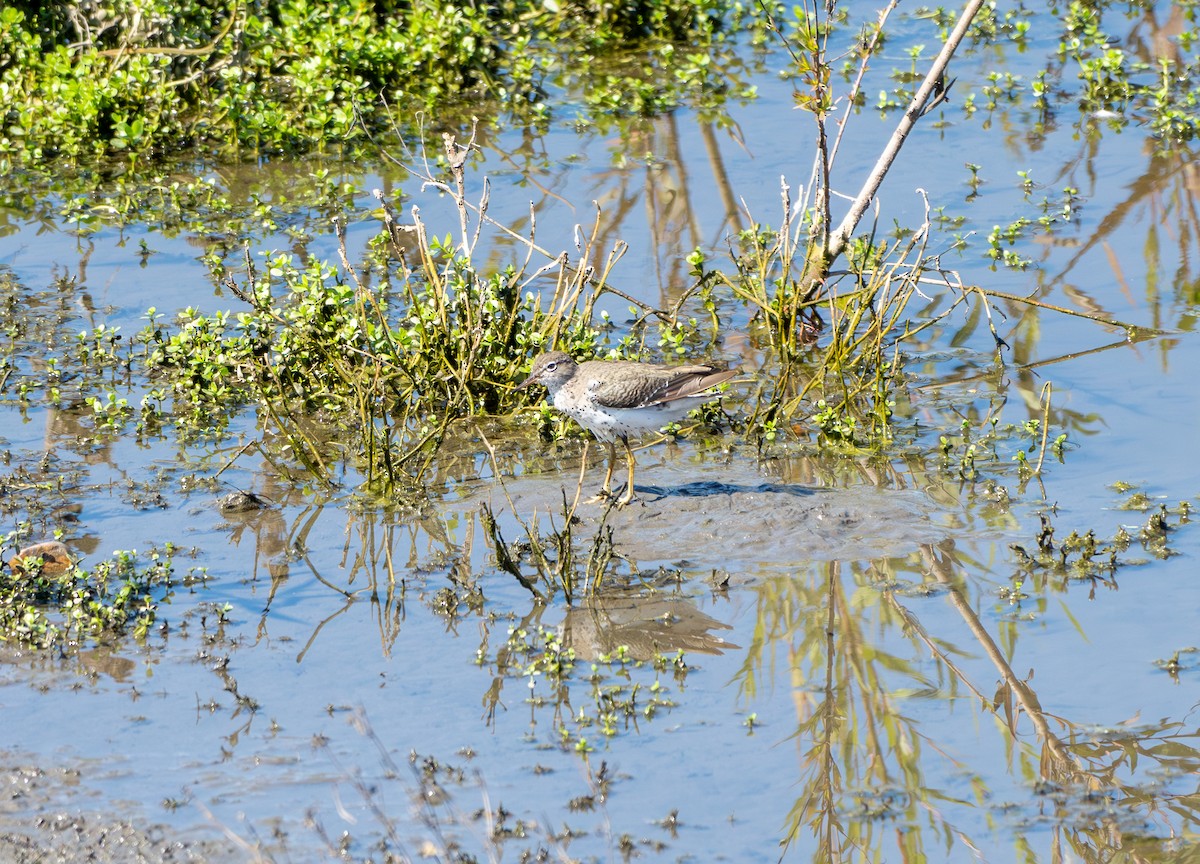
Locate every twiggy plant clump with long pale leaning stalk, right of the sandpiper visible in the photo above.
<box><xmin>690</xmin><ymin>1</ymin><xmax>1171</xmax><ymax>451</ymax></box>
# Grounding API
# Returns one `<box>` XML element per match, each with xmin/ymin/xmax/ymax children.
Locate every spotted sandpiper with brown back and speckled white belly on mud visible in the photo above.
<box><xmin>517</xmin><ymin>352</ymin><xmax>737</xmax><ymax>505</ymax></box>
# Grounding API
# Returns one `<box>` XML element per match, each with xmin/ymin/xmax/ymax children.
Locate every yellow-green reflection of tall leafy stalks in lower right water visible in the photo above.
<box><xmin>739</xmin><ymin>542</ymin><xmax>1200</xmax><ymax>862</ymax></box>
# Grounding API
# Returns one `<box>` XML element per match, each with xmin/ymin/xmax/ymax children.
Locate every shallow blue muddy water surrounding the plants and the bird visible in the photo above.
<box><xmin>0</xmin><ymin>8</ymin><xmax>1200</xmax><ymax>862</ymax></box>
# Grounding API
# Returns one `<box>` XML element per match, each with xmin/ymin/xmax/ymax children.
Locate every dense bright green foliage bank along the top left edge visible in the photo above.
<box><xmin>0</xmin><ymin>0</ymin><xmax>758</xmax><ymax>164</ymax></box>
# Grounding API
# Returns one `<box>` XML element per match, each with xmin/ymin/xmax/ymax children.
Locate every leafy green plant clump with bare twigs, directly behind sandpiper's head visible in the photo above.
<box><xmin>140</xmin><ymin>137</ymin><xmax>609</xmax><ymax>491</ymax></box>
